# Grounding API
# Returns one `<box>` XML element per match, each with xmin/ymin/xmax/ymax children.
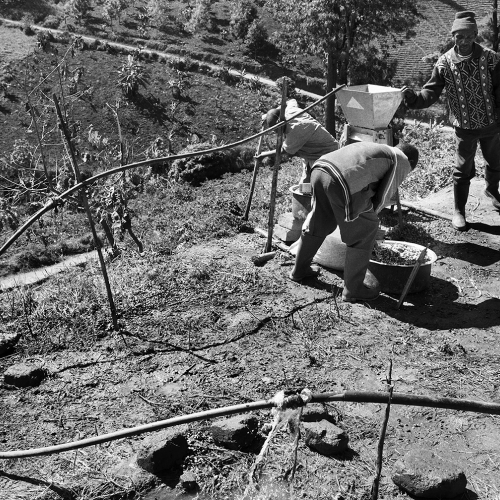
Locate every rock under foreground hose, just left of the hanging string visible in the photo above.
<box><xmin>210</xmin><ymin>415</ymin><xmax>258</xmax><ymax>450</ymax></box>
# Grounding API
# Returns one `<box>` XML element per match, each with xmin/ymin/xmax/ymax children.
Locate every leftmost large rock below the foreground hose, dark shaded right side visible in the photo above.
<box><xmin>137</xmin><ymin>426</ymin><xmax>189</xmax><ymax>475</ymax></box>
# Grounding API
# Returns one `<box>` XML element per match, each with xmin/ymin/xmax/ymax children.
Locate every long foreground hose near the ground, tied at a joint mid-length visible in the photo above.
<box><xmin>0</xmin><ymin>389</ymin><xmax>500</xmax><ymax>460</ymax></box>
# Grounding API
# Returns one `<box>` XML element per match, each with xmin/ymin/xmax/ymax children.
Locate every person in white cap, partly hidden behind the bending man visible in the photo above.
<box><xmin>261</xmin><ymin>99</ymin><xmax>339</xmax><ymax>184</ymax></box>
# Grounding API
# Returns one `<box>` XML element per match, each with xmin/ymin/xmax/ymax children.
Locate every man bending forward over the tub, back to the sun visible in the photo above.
<box><xmin>290</xmin><ymin>142</ymin><xmax>418</xmax><ymax>302</ymax></box>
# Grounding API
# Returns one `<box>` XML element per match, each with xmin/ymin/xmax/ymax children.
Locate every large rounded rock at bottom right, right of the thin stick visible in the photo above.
<box><xmin>392</xmin><ymin>448</ymin><xmax>467</xmax><ymax>498</ymax></box>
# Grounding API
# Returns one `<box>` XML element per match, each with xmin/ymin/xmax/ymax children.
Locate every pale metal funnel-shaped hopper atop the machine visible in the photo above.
<box><xmin>337</xmin><ymin>84</ymin><xmax>403</xmax><ymax>130</ymax></box>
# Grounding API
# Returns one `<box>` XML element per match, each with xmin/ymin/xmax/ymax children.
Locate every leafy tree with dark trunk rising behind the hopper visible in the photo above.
<box><xmin>266</xmin><ymin>0</ymin><xmax>419</xmax><ymax>133</ymax></box>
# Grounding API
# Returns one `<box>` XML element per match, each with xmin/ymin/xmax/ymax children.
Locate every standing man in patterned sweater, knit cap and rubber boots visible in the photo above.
<box><xmin>401</xmin><ymin>11</ymin><xmax>500</xmax><ymax>231</ymax></box>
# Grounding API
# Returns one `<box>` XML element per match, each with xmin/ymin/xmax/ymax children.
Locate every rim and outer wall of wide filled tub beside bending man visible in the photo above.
<box><xmin>368</xmin><ymin>240</ymin><xmax>437</xmax><ymax>294</ymax></box>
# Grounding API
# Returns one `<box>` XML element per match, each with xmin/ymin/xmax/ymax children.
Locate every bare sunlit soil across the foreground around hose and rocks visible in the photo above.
<box><xmin>0</xmin><ymin>193</ymin><xmax>500</xmax><ymax>500</ymax></box>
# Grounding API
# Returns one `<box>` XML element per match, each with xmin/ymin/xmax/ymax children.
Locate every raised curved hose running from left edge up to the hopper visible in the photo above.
<box><xmin>0</xmin><ymin>84</ymin><xmax>345</xmax><ymax>255</ymax></box>
